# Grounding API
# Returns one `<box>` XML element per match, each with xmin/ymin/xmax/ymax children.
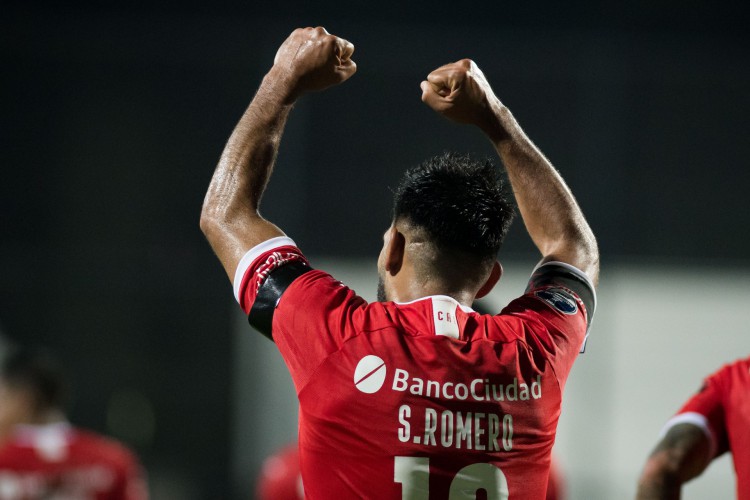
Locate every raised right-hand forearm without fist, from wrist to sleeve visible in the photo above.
<box><xmin>488</xmin><ymin>101</ymin><xmax>599</xmax><ymax>282</ymax></box>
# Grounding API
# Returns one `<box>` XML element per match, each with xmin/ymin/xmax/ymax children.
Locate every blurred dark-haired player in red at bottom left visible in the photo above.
<box><xmin>0</xmin><ymin>350</ymin><xmax>148</xmax><ymax>500</ymax></box>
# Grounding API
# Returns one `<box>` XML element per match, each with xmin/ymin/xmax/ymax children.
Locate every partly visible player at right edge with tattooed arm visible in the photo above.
<box><xmin>637</xmin><ymin>357</ymin><xmax>750</xmax><ymax>500</ymax></box>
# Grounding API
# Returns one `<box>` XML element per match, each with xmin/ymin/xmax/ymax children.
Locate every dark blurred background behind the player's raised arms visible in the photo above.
<box><xmin>0</xmin><ymin>0</ymin><xmax>750</xmax><ymax>498</ymax></box>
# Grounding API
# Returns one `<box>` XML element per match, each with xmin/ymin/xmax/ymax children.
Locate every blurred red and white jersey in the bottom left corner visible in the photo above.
<box><xmin>0</xmin><ymin>423</ymin><xmax>148</xmax><ymax>500</ymax></box>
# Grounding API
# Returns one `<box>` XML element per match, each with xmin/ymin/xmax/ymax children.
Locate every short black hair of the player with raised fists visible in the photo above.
<box><xmin>393</xmin><ymin>152</ymin><xmax>515</xmax><ymax>260</ymax></box>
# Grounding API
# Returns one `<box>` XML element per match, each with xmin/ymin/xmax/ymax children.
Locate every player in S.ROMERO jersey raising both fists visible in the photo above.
<box><xmin>201</xmin><ymin>27</ymin><xmax>599</xmax><ymax>500</ymax></box>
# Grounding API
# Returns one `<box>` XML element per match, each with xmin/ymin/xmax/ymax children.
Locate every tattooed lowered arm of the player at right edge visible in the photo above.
<box><xmin>636</xmin><ymin>423</ymin><xmax>711</xmax><ymax>500</ymax></box>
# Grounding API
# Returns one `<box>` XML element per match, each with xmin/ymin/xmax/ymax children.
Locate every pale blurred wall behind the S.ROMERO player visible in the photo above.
<box><xmin>234</xmin><ymin>259</ymin><xmax>750</xmax><ymax>500</ymax></box>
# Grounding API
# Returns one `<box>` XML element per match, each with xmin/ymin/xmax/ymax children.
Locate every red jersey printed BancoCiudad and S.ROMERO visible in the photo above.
<box><xmin>235</xmin><ymin>237</ymin><xmax>595</xmax><ymax>500</ymax></box>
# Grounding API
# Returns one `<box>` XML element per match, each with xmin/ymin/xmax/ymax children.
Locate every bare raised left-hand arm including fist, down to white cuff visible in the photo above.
<box><xmin>200</xmin><ymin>27</ymin><xmax>356</xmax><ymax>282</ymax></box>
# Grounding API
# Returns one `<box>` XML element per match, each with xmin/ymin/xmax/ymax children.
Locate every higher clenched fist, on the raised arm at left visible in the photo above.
<box><xmin>273</xmin><ymin>26</ymin><xmax>357</xmax><ymax>98</ymax></box>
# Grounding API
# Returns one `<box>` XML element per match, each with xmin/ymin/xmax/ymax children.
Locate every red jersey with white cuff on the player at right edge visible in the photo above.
<box><xmin>665</xmin><ymin>358</ymin><xmax>750</xmax><ymax>500</ymax></box>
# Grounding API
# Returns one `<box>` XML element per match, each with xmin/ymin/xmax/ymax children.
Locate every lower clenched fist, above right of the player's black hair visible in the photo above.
<box><xmin>420</xmin><ymin>59</ymin><xmax>501</xmax><ymax>128</ymax></box>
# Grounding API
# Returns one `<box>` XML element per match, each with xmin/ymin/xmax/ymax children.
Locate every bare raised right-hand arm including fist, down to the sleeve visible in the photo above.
<box><xmin>421</xmin><ymin>59</ymin><xmax>599</xmax><ymax>283</ymax></box>
